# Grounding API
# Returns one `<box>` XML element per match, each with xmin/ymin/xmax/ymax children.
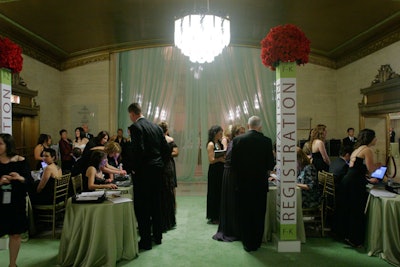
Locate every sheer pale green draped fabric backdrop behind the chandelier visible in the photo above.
<box><xmin>117</xmin><ymin>46</ymin><xmax>276</xmax><ymax>181</ymax></box>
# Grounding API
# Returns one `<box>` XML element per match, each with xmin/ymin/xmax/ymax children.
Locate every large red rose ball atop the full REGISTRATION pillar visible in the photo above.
<box><xmin>261</xmin><ymin>24</ymin><xmax>310</xmax><ymax>70</ymax></box>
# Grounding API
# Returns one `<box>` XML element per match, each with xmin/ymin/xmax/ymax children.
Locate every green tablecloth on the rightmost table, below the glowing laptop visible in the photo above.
<box><xmin>366</xmin><ymin>192</ymin><xmax>400</xmax><ymax>266</ymax></box>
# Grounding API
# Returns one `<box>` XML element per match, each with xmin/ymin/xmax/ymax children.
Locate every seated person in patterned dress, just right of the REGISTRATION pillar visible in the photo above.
<box><xmin>296</xmin><ymin>147</ymin><xmax>321</xmax><ymax>208</ymax></box>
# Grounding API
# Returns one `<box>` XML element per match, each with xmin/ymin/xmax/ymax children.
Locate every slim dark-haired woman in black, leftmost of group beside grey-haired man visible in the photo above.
<box><xmin>207</xmin><ymin>125</ymin><xmax>225</xmax><ymax>224</ymax></box>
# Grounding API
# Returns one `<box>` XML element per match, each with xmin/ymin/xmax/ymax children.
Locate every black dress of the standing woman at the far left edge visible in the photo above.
<box><xmin>0</xmin><ymin>160</ymin><xmax>33</xmax><ymax>237</ymax></box>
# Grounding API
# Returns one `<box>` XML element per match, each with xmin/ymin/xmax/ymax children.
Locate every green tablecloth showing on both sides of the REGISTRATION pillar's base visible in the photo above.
<box><xmin>263</xmin><ymin>187</ymin><xmax>306</xmax><ymax>243</ymax></box>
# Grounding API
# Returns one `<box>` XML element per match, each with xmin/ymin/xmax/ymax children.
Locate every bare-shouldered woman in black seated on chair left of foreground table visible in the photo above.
<box><xmin>31</xmin><ymin>148</ymin><xmax>62</xmax><ymax>205</ymax></box>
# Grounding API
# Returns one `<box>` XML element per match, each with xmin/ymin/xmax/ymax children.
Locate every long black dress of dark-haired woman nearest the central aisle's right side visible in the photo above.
<box><xmin>207</xmin><ymin>145</ymin><xmax>224</xmax><ymax>222</ymax></box>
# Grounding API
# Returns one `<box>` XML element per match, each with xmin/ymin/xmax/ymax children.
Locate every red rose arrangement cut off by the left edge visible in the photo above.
<box><xmin>0</xmin><ymin>37</ymin><xmax>23</xmax><ymax>73</ymax></box>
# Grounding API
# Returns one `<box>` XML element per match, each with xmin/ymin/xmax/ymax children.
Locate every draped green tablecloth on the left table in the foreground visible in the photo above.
<box><xmin>58</xmin><ymin>195</ymin><xmax>139</xmax><ymax>267</ymax></box>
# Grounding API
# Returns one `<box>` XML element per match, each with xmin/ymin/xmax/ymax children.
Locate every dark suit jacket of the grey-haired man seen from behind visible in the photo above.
<box><xmin>231</xmin><ymin>130</ymin><xmax>274</xmax><ymax>190</ymax></box>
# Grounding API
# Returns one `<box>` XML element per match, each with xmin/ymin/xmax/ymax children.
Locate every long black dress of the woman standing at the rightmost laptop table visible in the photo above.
<box><xmin>337</xmin><ymin>157</ymin><xmax>368</xmax><ymax>246</ymax></box>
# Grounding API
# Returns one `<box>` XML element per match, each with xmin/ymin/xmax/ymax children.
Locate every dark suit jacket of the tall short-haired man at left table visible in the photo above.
<box><xmin>129</xmin><ymin>118</ymin><xmax>170</xmax><ymax>174</ymax></box>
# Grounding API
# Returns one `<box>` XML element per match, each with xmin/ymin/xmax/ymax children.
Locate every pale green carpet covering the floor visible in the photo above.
<box><xmin>0</xmin><ymin>196</ymin><xmax>391</xmax><ymax>267</ymax></box>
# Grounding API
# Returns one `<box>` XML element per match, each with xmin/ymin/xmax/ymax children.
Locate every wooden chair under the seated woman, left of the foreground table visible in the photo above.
<box><xmin>33</xmin><ymin>173</ymin><xmax>71</xmax><ymax>238</ymax></box>
